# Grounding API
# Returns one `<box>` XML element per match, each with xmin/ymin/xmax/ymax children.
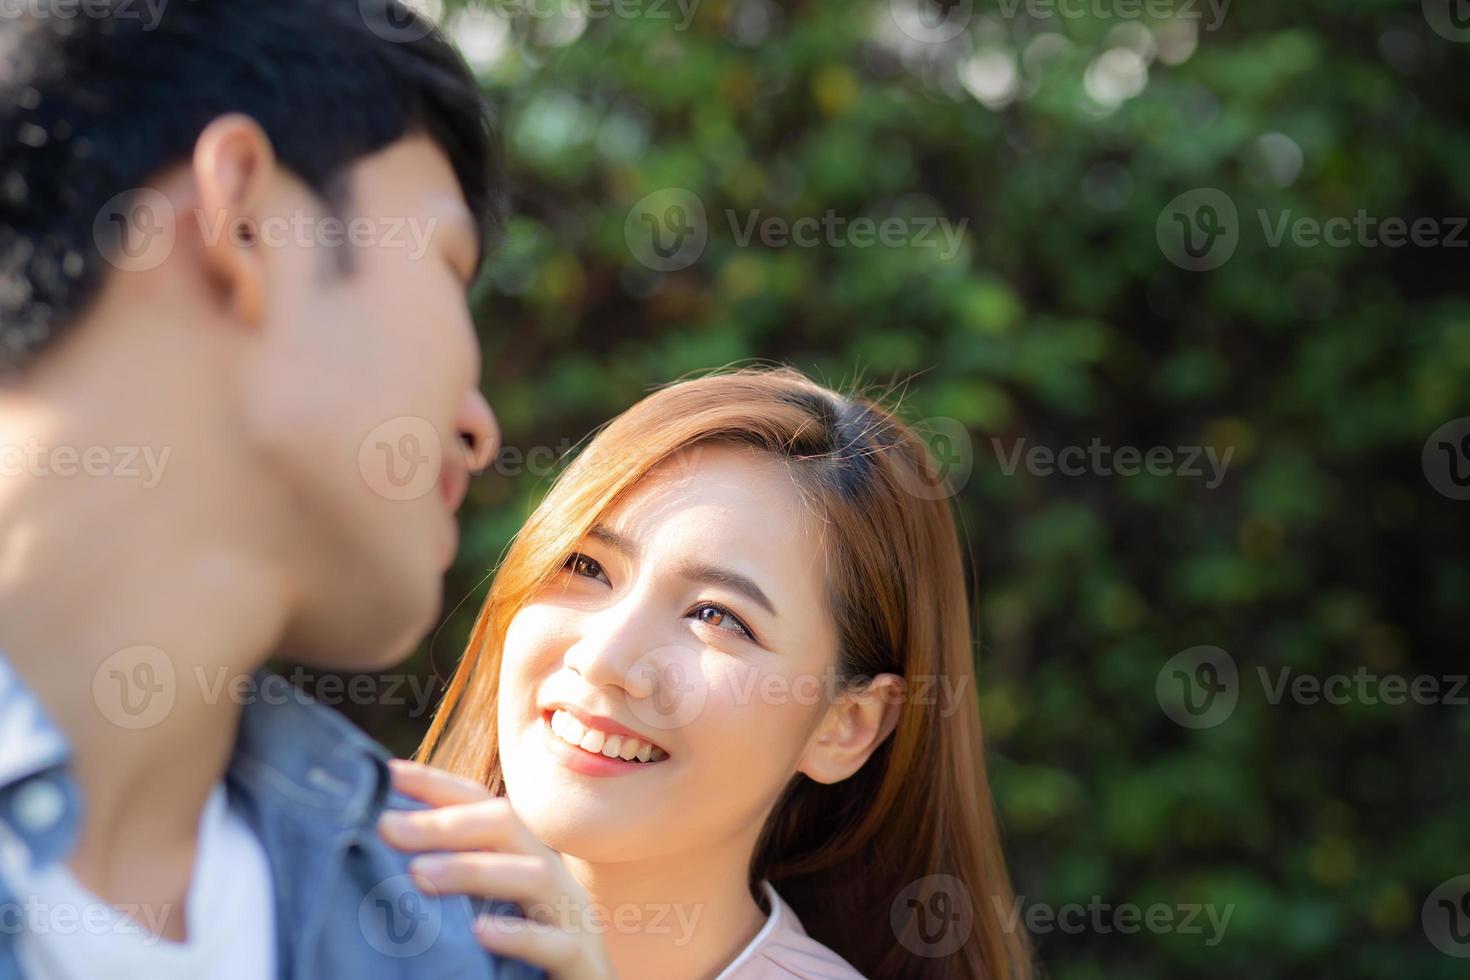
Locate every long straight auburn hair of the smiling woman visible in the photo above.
<box><xmin>419</xmin><ymin>369</ymin><xmax>1032</xmax><ymax>980</ymax></box>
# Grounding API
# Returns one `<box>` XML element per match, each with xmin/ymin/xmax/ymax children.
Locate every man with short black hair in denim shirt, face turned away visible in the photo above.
<box><xmin>0</xmin><ymin>0</ymin><xmax>529</xmax><ymax>980</ymax></box>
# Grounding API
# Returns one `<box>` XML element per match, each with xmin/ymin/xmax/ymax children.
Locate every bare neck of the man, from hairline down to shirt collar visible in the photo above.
<box><xmin>0</xmin><ymin>357</ymin><xmax>288</xmax><ymax>937</ymax></box>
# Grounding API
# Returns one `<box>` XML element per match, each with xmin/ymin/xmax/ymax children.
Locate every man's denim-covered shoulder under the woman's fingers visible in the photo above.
<box><xmin>229</xmin><ymin>676</ymin><xmax>542</xmax><ymax>980</ymax></box>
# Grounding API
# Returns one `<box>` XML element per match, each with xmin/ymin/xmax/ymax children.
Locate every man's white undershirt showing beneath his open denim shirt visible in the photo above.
<box><xmin>18</xmin><ymin>783</ymin><xmax>276</xmax><ymax>980</ymax></box>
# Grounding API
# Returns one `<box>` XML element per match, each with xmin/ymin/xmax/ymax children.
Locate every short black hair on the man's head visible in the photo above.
<box><xmin>0</xmin><ymin>0</ymin><xmax>501</xmax><ymax>376</ymax></box>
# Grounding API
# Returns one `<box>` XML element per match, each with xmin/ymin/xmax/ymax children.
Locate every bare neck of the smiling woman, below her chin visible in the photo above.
<box><xmin>566</xmin><ymin>840</ymin><xmax>766</xmax><ymax>980</ymax></box>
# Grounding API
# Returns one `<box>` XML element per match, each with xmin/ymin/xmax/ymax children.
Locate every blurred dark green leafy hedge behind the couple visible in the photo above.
<box><xmin>352</xmin><ymin>0</ymin><xmax>1470</xmax><ymax>980</ymax></box>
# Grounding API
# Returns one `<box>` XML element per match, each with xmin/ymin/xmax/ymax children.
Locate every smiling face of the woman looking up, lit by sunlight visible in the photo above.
<box><xmin>500</xmin><ymin>445</ymin><xmax>836</xmax><ymax>861</ymax></box>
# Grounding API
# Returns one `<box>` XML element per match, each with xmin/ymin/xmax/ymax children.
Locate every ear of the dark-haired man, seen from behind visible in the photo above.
<box><xmin>193</xmin><ymin>113</ymin><xmax>276</xmax><ymax>323</ymax></box>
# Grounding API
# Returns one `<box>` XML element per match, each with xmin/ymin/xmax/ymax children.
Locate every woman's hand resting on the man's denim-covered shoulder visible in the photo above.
<box><xmin>378</xmin><ymin>760</ymin><xmax>614</xmax><ymax>980</ymax></box>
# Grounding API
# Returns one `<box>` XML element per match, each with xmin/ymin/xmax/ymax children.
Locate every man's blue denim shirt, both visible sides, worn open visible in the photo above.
<box><xmin>0</xmin><ymin>657</ymin><xmax>544</xmax><ymax>980</ymax></box>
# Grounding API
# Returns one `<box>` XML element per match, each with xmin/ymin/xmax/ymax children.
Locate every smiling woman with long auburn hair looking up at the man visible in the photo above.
<box><xmin>384</xmin><ymin>370</ymin><xmax>1030</xmax><ymax>980</ymax></box>
